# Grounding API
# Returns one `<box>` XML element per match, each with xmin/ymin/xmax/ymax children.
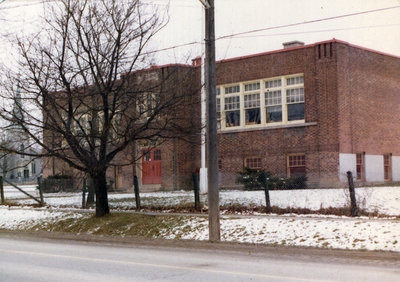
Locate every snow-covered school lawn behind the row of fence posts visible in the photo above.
<box><xmin>5</xmin><ymin>187</ymin><xmax>400</xmax><ymax>216</ymax></box>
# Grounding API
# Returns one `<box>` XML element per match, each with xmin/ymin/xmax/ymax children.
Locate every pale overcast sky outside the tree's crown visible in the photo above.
<box><xmin>0</xmin><ymin>0</ymin><xmax>400</xmax><ymax>64</ymax></box>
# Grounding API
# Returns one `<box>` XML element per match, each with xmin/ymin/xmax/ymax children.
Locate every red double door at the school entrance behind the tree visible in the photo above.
<box><xmin>142</xmin><ymin>149</ymin><xmax>161</xmax><ymax>184</ymax></box>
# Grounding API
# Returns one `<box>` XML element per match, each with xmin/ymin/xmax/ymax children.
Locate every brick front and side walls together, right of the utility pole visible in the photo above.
<box><xmin>217</xmin><ymin>41</ymin><xmax>400</xmax><ymax>187</ymax></box>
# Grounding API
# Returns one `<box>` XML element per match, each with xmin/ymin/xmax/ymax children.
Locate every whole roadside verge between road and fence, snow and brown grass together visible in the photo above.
<box><xmin>0</xmin><ymin>206</ymin><xmax>400</xmax><ymax>252</ymax></box>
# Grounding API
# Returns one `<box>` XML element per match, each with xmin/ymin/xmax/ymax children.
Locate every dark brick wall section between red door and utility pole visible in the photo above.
<box><xmin>138</xmin><ymin>66</ymin><xmax>200</xmax><ymax>190</ymax></box>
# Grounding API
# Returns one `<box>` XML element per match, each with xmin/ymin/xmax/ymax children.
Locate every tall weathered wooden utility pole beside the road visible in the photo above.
<box><xmin>200</xmin><ymin>0</ymin><xmax>221</xmax><ymax>242</ymax></box>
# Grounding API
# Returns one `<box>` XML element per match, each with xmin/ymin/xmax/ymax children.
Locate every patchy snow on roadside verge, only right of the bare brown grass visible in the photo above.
<box><xmin>166</xmin><ymin>216</ymin><xmax>400</xmax><ymax>252</ymax></box>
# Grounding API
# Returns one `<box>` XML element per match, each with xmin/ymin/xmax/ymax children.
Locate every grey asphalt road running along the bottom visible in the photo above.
<box><xmin>0</xmin><ymin>235</ymin><xmax>400</xmax><ymax>282</ymax></box>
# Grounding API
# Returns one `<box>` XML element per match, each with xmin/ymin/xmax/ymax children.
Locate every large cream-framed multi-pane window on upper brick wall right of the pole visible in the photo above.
<box><xmin>217</xmin><ymin>74</ymin><xmax>305</xmax><ymax>130</ymax></box>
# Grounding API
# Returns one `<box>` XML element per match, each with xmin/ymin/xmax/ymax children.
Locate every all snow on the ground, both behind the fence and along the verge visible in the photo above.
<box><xmin>0</xmin><ymin>186</ymin><xmax>400</xmax><ymax>252</ymax></box>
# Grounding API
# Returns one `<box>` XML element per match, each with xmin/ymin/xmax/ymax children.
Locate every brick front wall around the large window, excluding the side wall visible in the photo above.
<box><xmin>217</xmin><ymin>43</ymin><xmax>339</xmax><ymax>186</ymax></box>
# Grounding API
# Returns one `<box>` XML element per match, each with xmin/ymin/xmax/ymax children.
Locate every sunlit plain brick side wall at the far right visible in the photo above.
<box><xmin>338</xmin><ymin>44</ymin><xmax>400</xmax><ymax>156</ymax></box>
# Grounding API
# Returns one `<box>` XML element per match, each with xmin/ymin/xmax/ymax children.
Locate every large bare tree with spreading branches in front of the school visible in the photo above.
<box><xmin>0</xmin><ymin>0</ymin><xmax>199</xmax><ymax>216</ymax></box>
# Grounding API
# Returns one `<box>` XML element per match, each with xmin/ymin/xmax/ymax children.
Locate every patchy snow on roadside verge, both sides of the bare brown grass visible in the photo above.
<box><xmin>0</xmin><ymin>207</ymin><xmax>400</xmax><ymax>252</ymax></box>
